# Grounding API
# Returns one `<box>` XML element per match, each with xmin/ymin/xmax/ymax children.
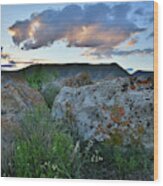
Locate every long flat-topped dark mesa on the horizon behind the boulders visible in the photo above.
<box><xmin>2</xmin><ymin>63</ymin><xmax>130</xmax><ymax>80</ymax></box>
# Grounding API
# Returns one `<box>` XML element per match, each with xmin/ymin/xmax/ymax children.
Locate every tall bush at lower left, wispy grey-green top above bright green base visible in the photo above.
<box><xmin>13</xmin><ymin>105</ymin><xmax>74</xmax><ymax>178</ymax></box>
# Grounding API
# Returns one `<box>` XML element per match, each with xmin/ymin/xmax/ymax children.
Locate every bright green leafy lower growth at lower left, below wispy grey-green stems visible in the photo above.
<box><xmin>14</xmin><ymin>133</ymin><xmax>73</xmax><ymax>178</ymax></box>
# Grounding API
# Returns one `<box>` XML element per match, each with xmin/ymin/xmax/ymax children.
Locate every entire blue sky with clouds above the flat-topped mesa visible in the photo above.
<box><xmin>1</xmin><ymin>1</ymin><xmax>154</xmax><ymax>72</ymax></box>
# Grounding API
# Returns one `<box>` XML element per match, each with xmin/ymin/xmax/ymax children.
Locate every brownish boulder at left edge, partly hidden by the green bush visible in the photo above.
<box><xmin>1</xmin><ymin>75</ymin><xmax>45</xmax><ymax>171</ymax></box>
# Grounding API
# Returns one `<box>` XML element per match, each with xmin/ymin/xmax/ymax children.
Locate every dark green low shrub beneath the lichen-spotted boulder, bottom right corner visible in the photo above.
<box><xmin>93</xmin><ymin>142</ymin><xmax>153</xmax><ymax>180</ymax></box>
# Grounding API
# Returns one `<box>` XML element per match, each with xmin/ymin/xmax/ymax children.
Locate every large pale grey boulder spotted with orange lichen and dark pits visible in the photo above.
<box><xmin>52</xmin><ymin>78</ymin><xmax>153</xmax><ymax>149</ymax></box>
